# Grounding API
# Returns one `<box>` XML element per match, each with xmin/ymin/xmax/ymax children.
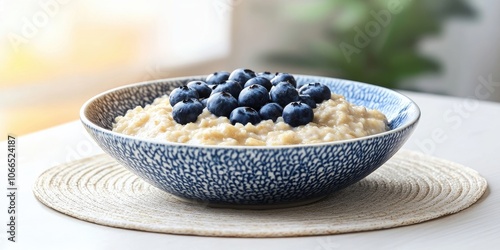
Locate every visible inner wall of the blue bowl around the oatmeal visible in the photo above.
<box><xmin>81</xmin><ymin>75</ymin><xmax>420</xmax><ymax>135</ymax></box>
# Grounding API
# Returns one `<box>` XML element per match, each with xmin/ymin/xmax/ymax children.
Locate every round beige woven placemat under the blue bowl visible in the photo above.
<box><xmin>34</xmin><ymin>150</ymin><xmax>487</xmax><ymax>237</ymax></box>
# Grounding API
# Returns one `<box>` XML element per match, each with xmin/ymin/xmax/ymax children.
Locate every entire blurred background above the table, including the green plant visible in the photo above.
<box><xmin>0</xmin><ymin>0</ymin><xmax>500</xmax><ymax>135</ymax></box>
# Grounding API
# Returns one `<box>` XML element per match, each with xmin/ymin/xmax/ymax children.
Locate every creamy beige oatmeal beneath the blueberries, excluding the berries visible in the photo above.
<box><xmin>113</xmin><ymin>94</ymin><xmax>387</xmax><ymax>146</ymax></box>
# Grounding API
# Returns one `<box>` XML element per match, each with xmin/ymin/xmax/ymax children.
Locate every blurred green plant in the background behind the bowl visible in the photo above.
<box><xmin>267</xmin><ymin>0</ymin><xmax>474</xmax><ymax>88</ymax></box>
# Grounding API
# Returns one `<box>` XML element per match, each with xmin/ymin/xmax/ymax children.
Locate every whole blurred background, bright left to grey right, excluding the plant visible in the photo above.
<box><xmin>0</xmin><ymin>0</ymin><xmax>500</xmax><ymax>137</ymax></box>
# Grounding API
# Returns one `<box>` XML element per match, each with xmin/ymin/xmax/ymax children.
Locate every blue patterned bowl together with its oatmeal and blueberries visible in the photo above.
<box><xmin>80</xmin><ymin>69</ymin><xmax>420</xmax><ymax>208</ymax></box>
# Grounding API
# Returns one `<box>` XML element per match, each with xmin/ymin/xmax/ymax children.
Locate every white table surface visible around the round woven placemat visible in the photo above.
<box><xmin>0</xmin><ymin>91</ymin><xmax>500</xmax><ymax>250</ymax></box>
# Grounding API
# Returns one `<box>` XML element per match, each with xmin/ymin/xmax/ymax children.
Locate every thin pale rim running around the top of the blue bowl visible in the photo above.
<box><xmin>79</xmin><ymin>74</ymin><xmax>421</xmax><ymax>150</ymax></box>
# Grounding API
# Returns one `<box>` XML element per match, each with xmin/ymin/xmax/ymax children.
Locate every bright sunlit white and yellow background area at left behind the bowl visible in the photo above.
<box><xmin>0</xmin><ymin>0</ymin><xmax>231</xmax><ymax>134</ymax></box>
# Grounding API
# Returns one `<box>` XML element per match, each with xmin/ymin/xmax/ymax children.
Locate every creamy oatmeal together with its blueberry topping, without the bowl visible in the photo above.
<box><xmin>113</xmin><ymin>69</ymin><xmax>388</xmax><ymax>146</ymax></box>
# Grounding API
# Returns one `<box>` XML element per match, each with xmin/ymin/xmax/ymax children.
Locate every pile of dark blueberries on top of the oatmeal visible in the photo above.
<box><xmin>169</xmin><ymin>69</ymin><xmax>331</xmax><ymax>127</ymax></box>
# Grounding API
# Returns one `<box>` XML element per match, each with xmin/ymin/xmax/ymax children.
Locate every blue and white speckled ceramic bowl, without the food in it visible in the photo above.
<box><xmin>80</xmin><ymin>75</ymin><xmax>420</xmax><ymax>207</ymax></box>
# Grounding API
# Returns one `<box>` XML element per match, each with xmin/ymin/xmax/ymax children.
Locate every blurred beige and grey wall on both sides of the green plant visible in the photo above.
<box><xmin>230</xmin><ymin>0</ymin><xmax>500</xmax><ymax>101</ymax></box>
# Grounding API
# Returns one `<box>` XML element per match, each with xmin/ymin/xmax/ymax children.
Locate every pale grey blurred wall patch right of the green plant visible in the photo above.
<box><xmin>411</xmin><ymin>0</ymin><xmax>500</xmax><ymax>102</ymax></box>
